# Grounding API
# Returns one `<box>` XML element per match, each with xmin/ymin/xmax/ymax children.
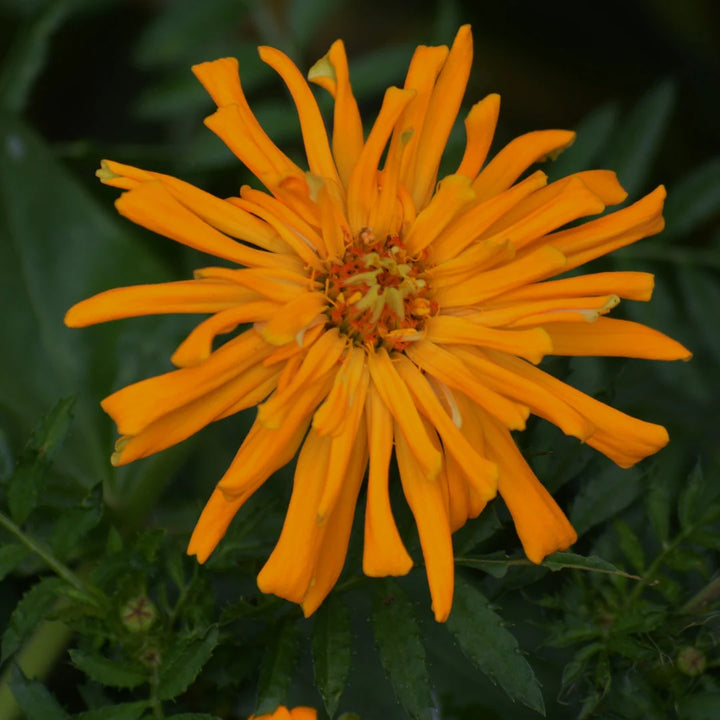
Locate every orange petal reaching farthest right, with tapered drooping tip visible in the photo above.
<box><xmin>543</xmin><ymin>317</ymin><xmax>692</xmax><ymax>360</ymax></box>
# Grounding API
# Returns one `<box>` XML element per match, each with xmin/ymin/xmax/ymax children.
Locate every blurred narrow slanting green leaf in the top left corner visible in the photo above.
<box><xmin>0</xmin><ymin>0</ymin><xmax>74</xmax><ymax>113</ymax></box>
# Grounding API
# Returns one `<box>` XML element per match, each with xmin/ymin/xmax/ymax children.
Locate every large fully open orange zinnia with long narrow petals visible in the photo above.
<box><xmin>66</xmin><ymin>26</ymin><xmax>689</xmax><ymax>620</ymax></box>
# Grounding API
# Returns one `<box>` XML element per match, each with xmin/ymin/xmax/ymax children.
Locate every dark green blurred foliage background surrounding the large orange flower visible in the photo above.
<box><xmin>0</xmin><ymin>0</ymin><xmax>720</xmax><ymax>720</ymax></box>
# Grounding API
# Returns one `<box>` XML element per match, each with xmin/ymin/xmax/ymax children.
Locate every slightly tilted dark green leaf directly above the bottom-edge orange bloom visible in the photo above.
<box><xmin>255</xmin><ymin>620</ymin><xmax>300</xmax><ymax>715</ymax></box>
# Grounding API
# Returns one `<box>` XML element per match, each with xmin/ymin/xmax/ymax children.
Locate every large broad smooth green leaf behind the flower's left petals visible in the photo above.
<box><xmin>0</xmin><ymin>112</ymin><xmax>169</xmax><ymax>487</ymax></box>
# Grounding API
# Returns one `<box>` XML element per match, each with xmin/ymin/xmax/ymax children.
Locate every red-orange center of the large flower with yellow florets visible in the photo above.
<box><xmin>319</xmin><ymin>227</ymin><xmax>438</xmax><ymax>350</ymax></box>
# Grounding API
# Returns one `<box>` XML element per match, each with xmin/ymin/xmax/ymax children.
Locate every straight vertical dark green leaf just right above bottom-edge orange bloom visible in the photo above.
<box><xmin>312</xmin><ymin>595</ymin><xmax>352</xmax><ymax>718</ymax></box>
